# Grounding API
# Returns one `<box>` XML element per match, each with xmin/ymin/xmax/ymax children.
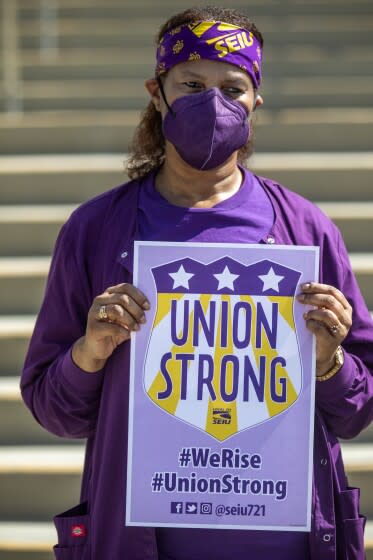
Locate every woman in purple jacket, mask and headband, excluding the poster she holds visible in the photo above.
<box><xmin>21</xmin><ymin>7</ymin><xmax>373</xmax><ymax>560</ymax></box>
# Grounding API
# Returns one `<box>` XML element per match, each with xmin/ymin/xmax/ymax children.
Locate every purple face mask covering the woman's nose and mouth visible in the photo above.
<box><xmin>163</xmin><ymin>88</ymin><xmax>250</xmax><ymax>170</ymax></box>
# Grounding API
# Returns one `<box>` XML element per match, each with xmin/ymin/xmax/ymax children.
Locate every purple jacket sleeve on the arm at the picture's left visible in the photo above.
<box><xmin>21</xmin><ymin>217</ymin><xmax>103</xmax><ymax>438</ymax></box>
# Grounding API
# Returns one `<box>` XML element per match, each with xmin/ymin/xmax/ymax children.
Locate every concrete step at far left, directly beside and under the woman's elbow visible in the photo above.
<box><xmin>0</xmin><ymin>376</ymin><xmax>82</xmax><ymax>446</ymax></box>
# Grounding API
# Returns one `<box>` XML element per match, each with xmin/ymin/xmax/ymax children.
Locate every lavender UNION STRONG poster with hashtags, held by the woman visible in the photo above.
<box><xmin>126</xmin><ymin>241</ymin><xmax>319</xmax><ymax>531</ymax></box>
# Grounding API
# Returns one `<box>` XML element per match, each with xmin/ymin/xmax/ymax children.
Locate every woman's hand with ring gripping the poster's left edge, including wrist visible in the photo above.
<box><xmin>72</xmin><ymin>284</ymin><xmax>150</xmax><ymax>372</ymax></box>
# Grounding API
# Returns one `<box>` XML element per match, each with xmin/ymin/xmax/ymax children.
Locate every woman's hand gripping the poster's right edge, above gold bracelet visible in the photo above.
<box><xmin>297</xmin><ymin>282</ymin><xmax>352</xmax><ymax>376</ymax></box>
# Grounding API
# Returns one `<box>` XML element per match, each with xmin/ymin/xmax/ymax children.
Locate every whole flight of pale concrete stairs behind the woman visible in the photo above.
<box><xmin>0</xmin><ymin>0</ymin><xmax>373</xmax><ymax>560</ymax></box>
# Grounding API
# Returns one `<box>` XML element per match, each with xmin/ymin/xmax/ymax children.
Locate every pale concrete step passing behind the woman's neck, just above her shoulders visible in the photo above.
<box><xmin>0</xmin><ymin>152</ymin><xmax>373</xmax><ymax>205</ymax></box>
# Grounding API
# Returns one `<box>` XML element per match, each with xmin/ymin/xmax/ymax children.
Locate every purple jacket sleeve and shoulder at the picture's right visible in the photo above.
<box><xmin>263</xmin><ymin>179</ymin><xmax>373</xmax><ymax>439</ymax></box>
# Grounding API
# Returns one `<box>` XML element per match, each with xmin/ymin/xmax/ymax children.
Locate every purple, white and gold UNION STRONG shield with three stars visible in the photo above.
<box><xmin>143</xmin><ymin>257</ymin><xmax>302</xmax><ymax>441</ymax></box>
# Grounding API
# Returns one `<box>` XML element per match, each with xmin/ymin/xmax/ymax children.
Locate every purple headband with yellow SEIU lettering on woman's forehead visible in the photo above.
<box><xmin>155</xmin><ymin>21</ymin><xmax>262</xmax><ymax>89</ymax></box>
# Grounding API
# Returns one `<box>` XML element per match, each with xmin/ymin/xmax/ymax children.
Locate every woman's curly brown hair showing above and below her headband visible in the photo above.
<box><xmin>126</xmin><ymin>6</ymin><xmax>263</xmax><ymax>179</ymax></box>
